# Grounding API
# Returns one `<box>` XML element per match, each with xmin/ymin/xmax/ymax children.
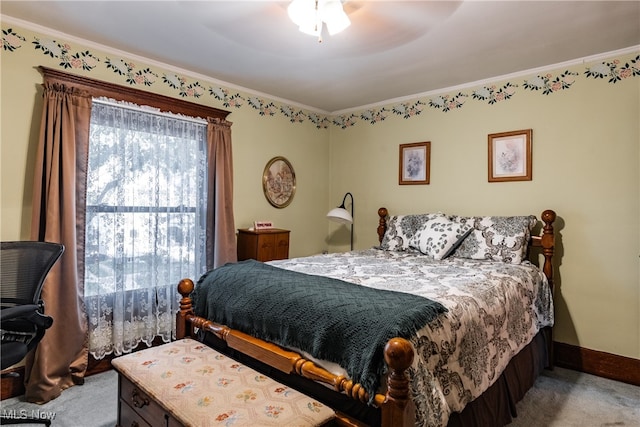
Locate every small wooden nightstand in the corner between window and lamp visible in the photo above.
<box><xmin>238</xmin><ymin>228</ymin><xmax>290</xmax><ymax>262</ymax></box>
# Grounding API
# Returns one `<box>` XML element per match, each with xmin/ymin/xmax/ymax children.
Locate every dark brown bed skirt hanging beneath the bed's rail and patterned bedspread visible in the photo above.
<box><xmin>199</xmin><ymin>331</ymin><xmax>550</xmax><ymax>427</ymax></box>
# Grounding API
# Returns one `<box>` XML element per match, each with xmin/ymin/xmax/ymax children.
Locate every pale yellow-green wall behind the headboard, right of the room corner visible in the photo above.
<box><xmin>330</xmin><ymin>54</ymin><xmax>640</xmax><ymax>359</ymax></box>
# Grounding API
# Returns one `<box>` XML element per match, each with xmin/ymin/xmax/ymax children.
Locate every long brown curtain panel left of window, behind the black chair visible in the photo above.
<box><xmin>25</xmin><ymin>81</ymin><xmax>92</xmax><ymax>403</ymax></box>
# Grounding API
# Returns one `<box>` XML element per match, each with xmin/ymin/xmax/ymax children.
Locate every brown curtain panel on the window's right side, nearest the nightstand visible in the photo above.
<box><xmin>207</xmin><ymin>118</ymin><xmax>238</xmax><ymax>269</ymax></box>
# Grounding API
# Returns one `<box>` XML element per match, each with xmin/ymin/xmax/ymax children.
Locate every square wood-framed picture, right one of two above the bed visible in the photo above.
<box><xmin>489</xmin><ymin>129</ymin><xmax>532</xmax><ymax>182</ymax></box>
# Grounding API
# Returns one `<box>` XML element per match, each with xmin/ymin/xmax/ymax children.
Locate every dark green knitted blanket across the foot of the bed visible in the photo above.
<box><xmin>191</xmin><ymin>260</ymin><xmax>446</xmax><ymax>398</ymax></box>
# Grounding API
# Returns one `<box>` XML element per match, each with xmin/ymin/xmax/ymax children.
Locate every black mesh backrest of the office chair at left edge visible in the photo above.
<box><xmin>0</xmin><ymin>241</ymin><xmax>64</xmax><ymax>307</ymax></box>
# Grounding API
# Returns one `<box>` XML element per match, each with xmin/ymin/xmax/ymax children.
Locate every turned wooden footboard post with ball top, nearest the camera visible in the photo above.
<box><xmin>382</xmin><ymin>338</ymin><xmax>414</xmax><ymax>426</ymax></box>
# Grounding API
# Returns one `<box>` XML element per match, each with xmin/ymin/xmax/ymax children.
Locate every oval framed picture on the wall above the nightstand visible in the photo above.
<box><xmin>262</xmin><ymin>156</ymin><xmax>296</xmax><ymax>209</ymax></box>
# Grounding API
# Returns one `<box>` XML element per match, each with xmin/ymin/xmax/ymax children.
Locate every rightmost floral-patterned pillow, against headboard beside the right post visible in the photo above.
<box><xmin>451</xmin><ymin>215</ymin><xmax>537</xmax><ymax>264</ymax></box>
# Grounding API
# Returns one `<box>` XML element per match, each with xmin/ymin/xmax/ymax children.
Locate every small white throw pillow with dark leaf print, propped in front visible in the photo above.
<box><xmin>409</xmin><ymin>217</ymin><xmax>473</xmax><ymax>259</ymax></box>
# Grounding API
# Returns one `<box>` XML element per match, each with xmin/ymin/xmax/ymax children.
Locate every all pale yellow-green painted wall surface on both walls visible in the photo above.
<box><xmin>0</xmin><ymin>23</ymin><xmax>640</xmax><ymax>358</ymax></box>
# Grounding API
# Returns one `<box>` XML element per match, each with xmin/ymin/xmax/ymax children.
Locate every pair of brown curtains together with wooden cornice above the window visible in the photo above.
<box><xmin>25</xmin><ymin>67</ymin><xmax>237</xmax><ymax>403</ymax></box>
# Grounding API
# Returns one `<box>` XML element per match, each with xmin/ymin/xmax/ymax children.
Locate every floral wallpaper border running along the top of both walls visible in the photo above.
<box><xmin>2</xmin><ymin>28</ymin><xmax>640</xmax><ymax>129</ymax></box>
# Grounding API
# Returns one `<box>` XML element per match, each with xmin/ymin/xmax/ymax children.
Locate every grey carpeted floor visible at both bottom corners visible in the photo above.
<box><xmin>1</xmin><ymin>368</ymin><xmax>640</xmax><ymax>427</ymax></box>
